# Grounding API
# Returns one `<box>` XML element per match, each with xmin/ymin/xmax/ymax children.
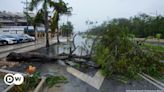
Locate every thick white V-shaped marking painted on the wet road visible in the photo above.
<box><xmin>67</xmin><ymin>67</ymin><xmax>105</xmax><ymax>90</ymax></box>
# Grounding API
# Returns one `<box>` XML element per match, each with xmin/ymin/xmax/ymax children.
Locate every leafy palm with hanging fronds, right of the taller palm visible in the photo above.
<box><xmin>50</xmin><ymin>0</ymin><xmax>72</xmax><ymax>43</ymax></box>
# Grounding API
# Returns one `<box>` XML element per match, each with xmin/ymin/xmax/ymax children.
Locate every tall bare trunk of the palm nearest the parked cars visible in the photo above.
<box><xmin>44</xmin><ymin>0</ymin><xmax>50</xmax><ymax>47</ymax></box>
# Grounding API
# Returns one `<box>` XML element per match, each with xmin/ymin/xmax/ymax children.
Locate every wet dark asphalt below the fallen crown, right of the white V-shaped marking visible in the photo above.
<box><xmin>101</xmin><ymin>79</ymin><xmax>160</xmax><ymax>92</ymax></box>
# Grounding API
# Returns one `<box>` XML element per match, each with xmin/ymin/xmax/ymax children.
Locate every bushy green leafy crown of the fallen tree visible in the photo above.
<box><xmin>93</xmin><ymin>26</ymin><xmax>164</xmax><ymax>78</ymax></box>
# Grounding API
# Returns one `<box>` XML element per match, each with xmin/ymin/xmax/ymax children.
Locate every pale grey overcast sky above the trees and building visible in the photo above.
<box><xmin>0</xmin><ymin>0</ymin><xmax>164</xmax><ymax>31</ymax></box>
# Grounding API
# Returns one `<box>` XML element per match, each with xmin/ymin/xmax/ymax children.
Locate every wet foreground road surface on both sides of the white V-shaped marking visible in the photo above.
<box><xmin>6</xmin><ymin>61</ymin><xmax>159</xmax><ymax>92</ymax></box>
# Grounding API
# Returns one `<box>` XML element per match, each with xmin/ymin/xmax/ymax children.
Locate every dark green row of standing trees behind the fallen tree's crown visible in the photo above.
<box><xmin>90</xmin><ymin>14</ymin><xmax>164</xmax><ymax>38</ymax></box>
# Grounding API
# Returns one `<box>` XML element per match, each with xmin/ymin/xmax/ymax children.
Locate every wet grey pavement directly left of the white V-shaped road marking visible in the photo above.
<box><xmin>40</xmin><ymin>64</ymin><xmax>99</xmax><ymax>92</ymax></box>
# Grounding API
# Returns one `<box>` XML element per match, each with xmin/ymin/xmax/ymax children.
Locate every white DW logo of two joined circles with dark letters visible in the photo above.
<box><xmin>4</xmin><ymin>74</ymin><xmax>24</xmax><ymax>85</ymax></box>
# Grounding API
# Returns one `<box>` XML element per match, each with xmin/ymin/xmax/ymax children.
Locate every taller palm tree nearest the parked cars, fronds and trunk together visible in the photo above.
<box><xmin>29</xmin><ymin>0</ymin><xmax>50</xmax><ymax>47</ymax></box>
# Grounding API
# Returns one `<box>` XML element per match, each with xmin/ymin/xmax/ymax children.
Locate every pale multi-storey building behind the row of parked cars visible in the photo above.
<box><xmin>0</xmin><ymin>11</ymin><xmax>54</xmax><ymax>38</ymax></box>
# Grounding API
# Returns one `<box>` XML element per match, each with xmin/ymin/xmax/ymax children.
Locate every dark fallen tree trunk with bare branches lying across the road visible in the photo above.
<box><xmin>6</xmin><ymin>34</ymin><xmax>99</xmax><ymax>68</ymax></box>
